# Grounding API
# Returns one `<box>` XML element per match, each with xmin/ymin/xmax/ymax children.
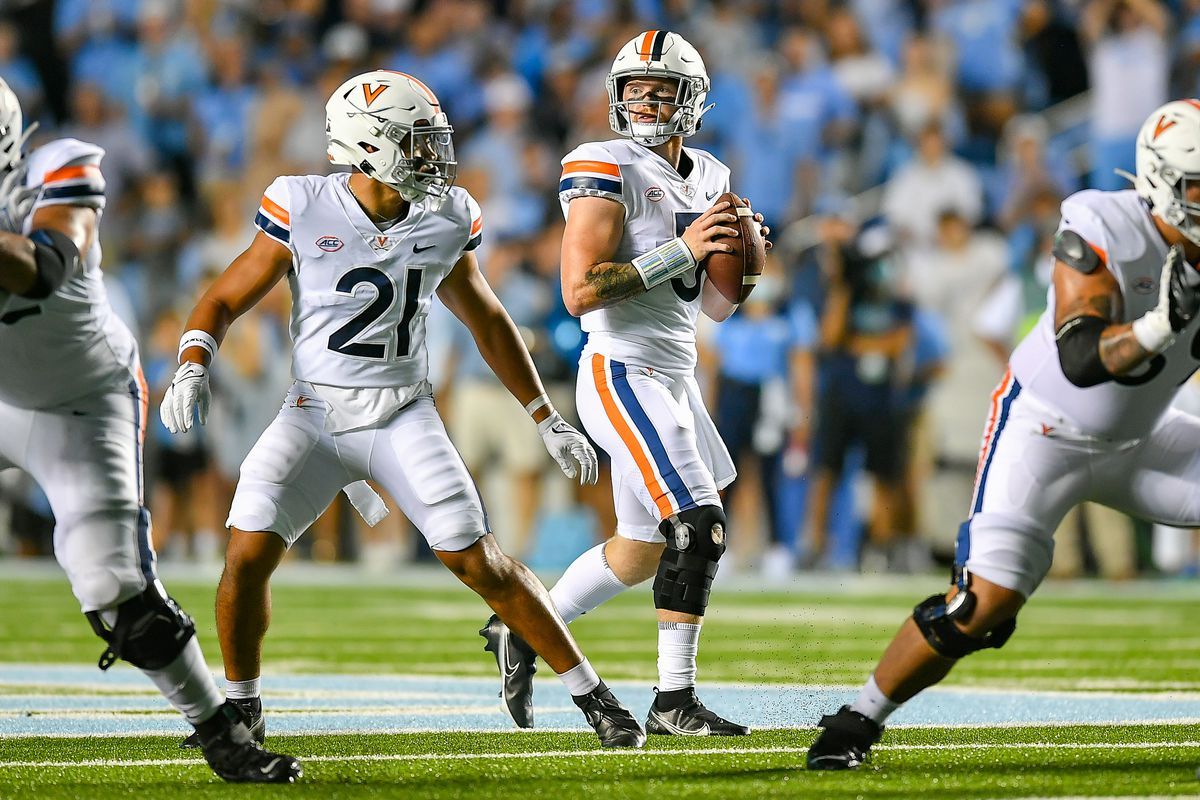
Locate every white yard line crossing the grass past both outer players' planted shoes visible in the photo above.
<box><xmin>0</xmin><ymin>741</ymin><xmax>1200</xmax><ymax>769</ymax></box>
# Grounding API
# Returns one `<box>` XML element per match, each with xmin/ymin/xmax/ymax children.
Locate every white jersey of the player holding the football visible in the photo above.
<box><xmin>558</xmin><ymin>139</ymin><xmax>730</xmax><ymax>373</ymax></box>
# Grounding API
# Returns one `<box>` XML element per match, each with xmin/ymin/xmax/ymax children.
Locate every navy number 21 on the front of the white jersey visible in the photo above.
<box><xmin>329</xmin><ymin>266</ymin><xmax>425</xmax><ymax>361</ymax></box>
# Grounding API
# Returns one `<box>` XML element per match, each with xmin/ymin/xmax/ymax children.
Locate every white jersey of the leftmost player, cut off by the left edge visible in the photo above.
<box><xmin>0</xmin><ymin>139</ymin><xmax>137</xmax><ymax>408</ymax></box>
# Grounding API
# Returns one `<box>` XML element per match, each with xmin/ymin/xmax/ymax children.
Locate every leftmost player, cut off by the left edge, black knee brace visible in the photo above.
<box><xmin>0</xmin><ymin>80</ymin><xmax>301</xmax><ymax>783</ymax></box>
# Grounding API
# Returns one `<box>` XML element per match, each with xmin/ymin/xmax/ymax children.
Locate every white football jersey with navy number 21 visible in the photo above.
<box><xmin>254</xmin><ymin>173</ymin><xmax>482</xmax><ymax>389</ymax></box>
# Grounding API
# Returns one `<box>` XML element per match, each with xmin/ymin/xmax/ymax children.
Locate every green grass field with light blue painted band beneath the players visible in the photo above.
<box><xmin>0</xmin><ymin>565</ymin><xmax>1200</xmax><ymax>800</ymax></box>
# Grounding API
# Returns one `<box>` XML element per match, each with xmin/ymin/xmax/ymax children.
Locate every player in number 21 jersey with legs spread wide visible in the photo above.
<box><xmin>161</xmin><ymin>71</ymin><xmax>646</xmax><ymax>747</ymax></box>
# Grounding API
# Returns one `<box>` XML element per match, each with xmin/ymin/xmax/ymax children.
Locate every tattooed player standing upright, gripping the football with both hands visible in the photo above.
<box><xmin>480</xmin><ymin>30</ymin><xmax>769</xmax><ymax>736</ymax></box>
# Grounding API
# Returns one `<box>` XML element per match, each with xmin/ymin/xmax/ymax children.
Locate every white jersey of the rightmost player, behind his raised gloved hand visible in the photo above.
<box><xmin>1012</xmin><ymin>190</ymin><xmax>1200</xmax><ymax>439</ymax></box>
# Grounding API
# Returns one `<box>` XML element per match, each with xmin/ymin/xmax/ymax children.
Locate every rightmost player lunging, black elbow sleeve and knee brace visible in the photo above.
<box><xmin>808</xmin><ymin>100</ymin><xmax>1200</xmax><ymax>770</ymax></box>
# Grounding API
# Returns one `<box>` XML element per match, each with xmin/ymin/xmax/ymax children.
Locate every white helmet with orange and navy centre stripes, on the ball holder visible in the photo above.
<box><xmin>605</xmin><ymin>30</ymin><xmax>713</xmax><ymax>148</ymax></box>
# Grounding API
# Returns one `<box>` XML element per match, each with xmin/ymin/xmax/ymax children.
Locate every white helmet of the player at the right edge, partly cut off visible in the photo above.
<box><xmin>1126</xmin><ymin>100</ymin><xmax>1200</xmax><ymax>245</ymax></box>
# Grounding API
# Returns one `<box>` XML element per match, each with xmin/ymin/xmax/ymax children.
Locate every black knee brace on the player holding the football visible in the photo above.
<box><xmin>654</xmin><ymin>506</ymin><xmax>725</xmax><ymax>616</ymax></box>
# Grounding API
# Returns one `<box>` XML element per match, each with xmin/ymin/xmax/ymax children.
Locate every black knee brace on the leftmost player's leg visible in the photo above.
<box><xmin>86</xmin><ymin>583</ymin><xmax>196</xmax><ymax>669</ymax></box>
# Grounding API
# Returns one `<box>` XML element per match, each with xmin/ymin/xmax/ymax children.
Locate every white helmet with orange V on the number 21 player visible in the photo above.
<box><xmin>325</xmin><ymin>70</ymin><xmax>458</xmax><ymax>207</ymax></box>
